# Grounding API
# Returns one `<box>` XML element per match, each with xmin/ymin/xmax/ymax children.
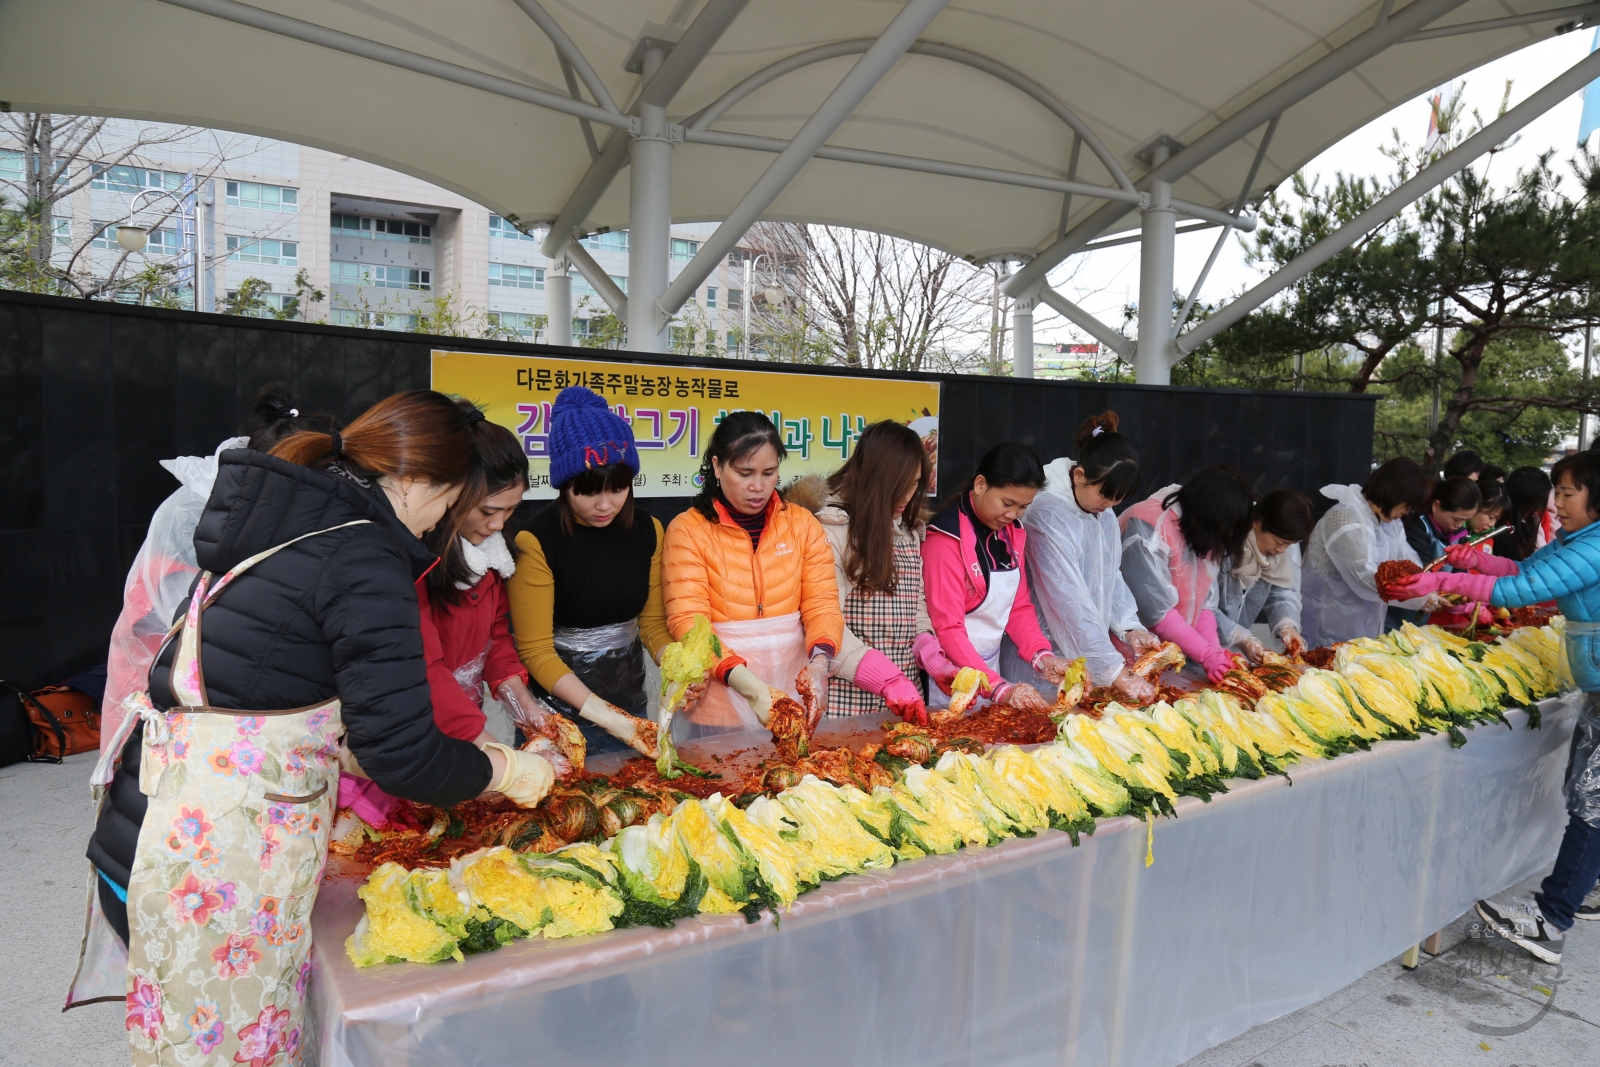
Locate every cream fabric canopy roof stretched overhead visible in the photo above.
<box><xmin>0</xmin><ymin>0</ymin><xmax>1574</xmax><ymax>259</ymax></box>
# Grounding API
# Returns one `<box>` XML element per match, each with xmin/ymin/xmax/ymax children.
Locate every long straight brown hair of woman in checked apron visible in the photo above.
<box><xmin>827</xmin><ymin>421</ymin><xmax>933</xmax><ymax>593</ymax></box>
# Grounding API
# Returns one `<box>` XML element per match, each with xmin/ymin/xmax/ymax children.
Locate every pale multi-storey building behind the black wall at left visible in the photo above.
<box><xmin>0</xmin><ymin>122</ymin><xmax>746</xmax><ymax>350</ymax></box>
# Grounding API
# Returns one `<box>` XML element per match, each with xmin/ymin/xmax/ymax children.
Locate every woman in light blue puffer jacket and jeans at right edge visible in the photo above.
<box><xmin>1397</xmin><ymin>453</ymin><xmax>1600</xmax><ymax>963</ymax></box>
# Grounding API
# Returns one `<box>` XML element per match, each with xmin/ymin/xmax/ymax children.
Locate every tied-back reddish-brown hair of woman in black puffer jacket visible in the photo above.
<box><xmin>270</xmin><ymin>389</ymin><xmax>478</xmax><ymax>485</ymax></box>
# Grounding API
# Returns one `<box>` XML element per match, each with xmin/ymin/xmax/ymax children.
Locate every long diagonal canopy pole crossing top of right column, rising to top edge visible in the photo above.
<box><xmin>1003</xmin><ymin>0</ymin><xmax>1466</xmax><ymax>294</ymax></box>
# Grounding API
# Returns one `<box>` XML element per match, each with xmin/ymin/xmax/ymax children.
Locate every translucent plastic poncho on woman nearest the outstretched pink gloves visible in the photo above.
<box><xmin>1301</xmin><ymin>485</ymin><xmax>1422</xmax><ymax>648</ymax></box>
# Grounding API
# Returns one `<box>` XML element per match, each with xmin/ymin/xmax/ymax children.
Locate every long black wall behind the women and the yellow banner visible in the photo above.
<box><xmin>0</xmin><ymin>293</ymin><xmax>1373</xmax><ymax>686</ymax></box>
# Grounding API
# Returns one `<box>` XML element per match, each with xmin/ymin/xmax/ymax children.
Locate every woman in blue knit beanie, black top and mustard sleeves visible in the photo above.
<box><xmin>509</xmin><ymin>387</ymin><xmax>691</xmax><ymax>757</ymax></box>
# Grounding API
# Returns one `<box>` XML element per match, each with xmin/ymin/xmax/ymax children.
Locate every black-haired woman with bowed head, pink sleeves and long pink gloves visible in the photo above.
<box><xmin>1122</xmin><ymin>464</ymin><xmax>1254</xmax><ymax>681</ymax></box>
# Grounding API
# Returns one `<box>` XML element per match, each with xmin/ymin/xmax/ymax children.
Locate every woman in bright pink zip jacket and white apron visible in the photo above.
<box><xmin>912</xmin><ymin>443</ymin><xmax>1067</xmax><ymax>710</ymax></box>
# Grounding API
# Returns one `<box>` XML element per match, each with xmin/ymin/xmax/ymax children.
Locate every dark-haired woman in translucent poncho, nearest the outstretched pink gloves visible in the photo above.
<box><xmin>1301</xmin><ymin>456</ymin><xmax>1438</xmax><ymax>648</ymax></box>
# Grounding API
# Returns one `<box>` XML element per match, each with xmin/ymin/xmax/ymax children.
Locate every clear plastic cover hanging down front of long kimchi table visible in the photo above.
<box><xmin>310</xmin><ymin>696</ymin><xmax>1578</xmax><ymax>1067</ymax></box>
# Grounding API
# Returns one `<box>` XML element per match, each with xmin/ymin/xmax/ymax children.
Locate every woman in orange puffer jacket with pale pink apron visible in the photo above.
<box><xmin>661</xmin><ymin>411</ymin><xmax>845</xmax><ymax>739</ymax></box>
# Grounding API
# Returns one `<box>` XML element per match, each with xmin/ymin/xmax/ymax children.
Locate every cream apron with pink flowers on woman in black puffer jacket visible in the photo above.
<box><xmin>128</xmin><ymin>520</ymin><xmax>365</xmax><ymax>1067</ymax></box>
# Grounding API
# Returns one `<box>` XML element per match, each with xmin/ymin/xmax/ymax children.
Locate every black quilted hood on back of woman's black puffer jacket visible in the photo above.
<box><xmin>195</xmin><ymin>448</ymin><xmax>438</xmax><ymax>581</ymax></box>
